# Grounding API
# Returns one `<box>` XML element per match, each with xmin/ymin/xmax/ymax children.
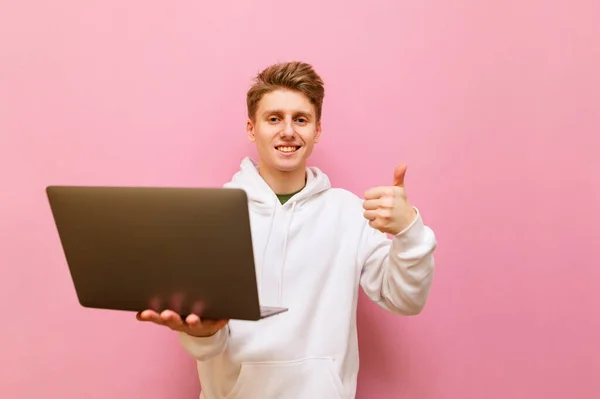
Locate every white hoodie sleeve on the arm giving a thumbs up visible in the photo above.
<box><xmin>358</xmin><ymin>208</ymin><xmax>437</xmax><ymax>315</ymax></box>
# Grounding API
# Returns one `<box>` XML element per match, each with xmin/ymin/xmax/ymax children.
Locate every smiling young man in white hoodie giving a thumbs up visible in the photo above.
<box><xmin>138</xmin><ymin>62</ymin><xmax>437</xmax><ymax>399</ymax></box>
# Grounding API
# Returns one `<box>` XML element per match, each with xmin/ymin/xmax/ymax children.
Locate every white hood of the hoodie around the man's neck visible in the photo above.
<box><xmin>224</xmin><ymin>157</ymin><xmax>331</xmax><ymax>211</ymax></box>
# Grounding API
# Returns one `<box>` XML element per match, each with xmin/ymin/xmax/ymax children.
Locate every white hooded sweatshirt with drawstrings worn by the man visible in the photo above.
<box><xmin>180</xmin><ymin>158</ymin><xmax>437</xmax><ymax>399</ymax></box>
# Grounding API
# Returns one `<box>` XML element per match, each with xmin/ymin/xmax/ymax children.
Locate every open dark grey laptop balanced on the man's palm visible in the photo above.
<box><xmin>46</xmin><ymin>186</ymin><xmax>288</xmax><ymax>320</ymax></box>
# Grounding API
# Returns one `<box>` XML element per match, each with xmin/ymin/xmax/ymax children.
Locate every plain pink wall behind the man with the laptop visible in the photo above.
<box><xmin>0</xmin><ymin>0</ymin><xmax>600</xmax><ymax>399</ymax></box>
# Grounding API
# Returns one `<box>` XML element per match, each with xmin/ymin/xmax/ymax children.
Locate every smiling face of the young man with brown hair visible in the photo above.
<box><xmin>246</xmin><ymin>89</ymin><xmax>321</xmax><ymax>176</ymax></box>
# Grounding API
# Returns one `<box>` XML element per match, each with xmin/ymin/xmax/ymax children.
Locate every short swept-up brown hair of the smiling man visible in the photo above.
<box><xmin>246</xmin><ymin>61</ymin><xmax>325</xmax><ymax>122</ymax></box>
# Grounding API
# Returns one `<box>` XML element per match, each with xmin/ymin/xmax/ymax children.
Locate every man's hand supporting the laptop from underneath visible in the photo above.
<box><xmin>136</xmin><ymin>310</ymin><xmax>229</xmax><ymax>337</ymax></box>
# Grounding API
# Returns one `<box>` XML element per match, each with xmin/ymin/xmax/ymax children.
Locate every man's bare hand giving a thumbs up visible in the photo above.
<box><xmin>363</xmin><ymin>163</ymin><xmax>417</xmax><ymax>235</ymax></box>
